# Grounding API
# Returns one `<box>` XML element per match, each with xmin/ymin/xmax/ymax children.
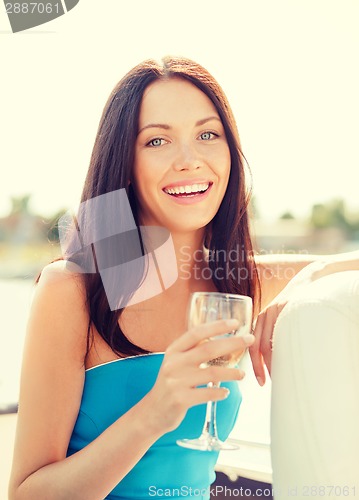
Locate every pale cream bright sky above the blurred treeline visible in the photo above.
<box><xmin>0</xmin><ymin>0</ymin><xmax>359</xmax><ymax>219</ymax></box>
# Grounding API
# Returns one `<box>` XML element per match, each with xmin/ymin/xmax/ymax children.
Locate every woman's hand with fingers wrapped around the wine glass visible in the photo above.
<box><xmin>147</xmin><ymin>319</ymin><xmax>254</xmax><ymax>432</ymax></box>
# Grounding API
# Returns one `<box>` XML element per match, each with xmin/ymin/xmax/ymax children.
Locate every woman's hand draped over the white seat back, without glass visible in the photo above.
<box><xmin>249</xmin><ymin>260</ymin><xmax>327</xmax><ymax>385</ymax></box>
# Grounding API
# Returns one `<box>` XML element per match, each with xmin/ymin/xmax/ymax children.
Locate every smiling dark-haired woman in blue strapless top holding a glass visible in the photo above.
<box><xmin>9</xmin><ymin>58</ymin><xmax>359</xmax><ymax>500</ymax></box>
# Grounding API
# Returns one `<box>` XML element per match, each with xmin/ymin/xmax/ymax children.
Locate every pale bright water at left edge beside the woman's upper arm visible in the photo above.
<box><xmin>0</xmin><ymin>280</ymin><xmax>33</xmax><ymax>413</ymax></box>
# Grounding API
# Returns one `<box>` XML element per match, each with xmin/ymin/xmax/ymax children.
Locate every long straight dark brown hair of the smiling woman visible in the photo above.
<box><xmin>42</xmin><ymin>57</ymin><xmax>259</xmax><ymax>356</ymax></box>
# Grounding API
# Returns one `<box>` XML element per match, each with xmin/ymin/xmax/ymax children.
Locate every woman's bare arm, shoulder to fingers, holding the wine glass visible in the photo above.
<box><xmin>9</xmin><ymin>263</ymin><xmax>253</xmax><ymax>500</ymax></box>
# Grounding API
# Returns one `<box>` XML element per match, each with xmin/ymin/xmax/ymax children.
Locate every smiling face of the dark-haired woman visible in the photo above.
<box><xmin>132</xmin><ymin>78</ymin><xmax>231</xmax><ymax>232</ymax></box>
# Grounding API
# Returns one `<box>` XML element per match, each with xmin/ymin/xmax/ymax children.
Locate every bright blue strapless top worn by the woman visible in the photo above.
<box><xmin>67</xmin><ymin>353</ymin><xmax>242</xmax><ymax>500</ymax></box>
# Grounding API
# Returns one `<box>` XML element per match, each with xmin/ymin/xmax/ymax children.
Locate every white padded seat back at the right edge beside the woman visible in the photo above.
<box><xmin>271</xmin><ymin>271</ymin><xmax>359</xmax><ymax>500</ymax></box>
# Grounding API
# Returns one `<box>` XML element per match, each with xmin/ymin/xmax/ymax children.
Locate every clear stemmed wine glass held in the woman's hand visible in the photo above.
<box><xmin>177</xmin><ymin>292</ymin><xmax>252</xmax><ymax>451</ymax></box>
